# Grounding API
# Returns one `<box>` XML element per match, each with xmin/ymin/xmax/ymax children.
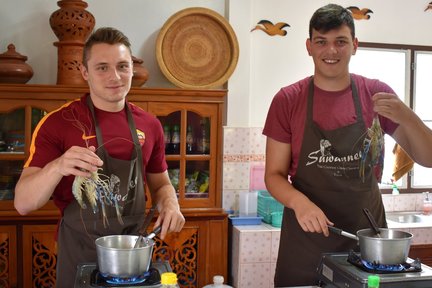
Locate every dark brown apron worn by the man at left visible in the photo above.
<box><xmin>56</xmin><ymin>97</ymin><xmax>149</xmax><ymax>288</ymax></box>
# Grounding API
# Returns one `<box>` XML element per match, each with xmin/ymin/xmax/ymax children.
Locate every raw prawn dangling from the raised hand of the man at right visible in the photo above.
<box><xmin>359</xmin><ymin>115</ymin><xmax>384</xmax><ymax>182</ymax></box>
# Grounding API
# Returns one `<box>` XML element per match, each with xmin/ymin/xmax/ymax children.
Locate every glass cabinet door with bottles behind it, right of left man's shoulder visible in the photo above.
<box><xmin>148</xmin><ymin>103</ymin><xmax>217</xmax><ymax>207</ymax></box>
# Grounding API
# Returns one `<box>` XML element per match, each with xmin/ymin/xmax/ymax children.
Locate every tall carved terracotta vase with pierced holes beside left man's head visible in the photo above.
<box><xmin>50</xmin><ymin>0</ymin><xmax>95</xmax><ymax>85</ymax></box>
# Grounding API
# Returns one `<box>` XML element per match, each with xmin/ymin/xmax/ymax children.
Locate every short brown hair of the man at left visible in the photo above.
<box><xmin>83</xmin><ymin>27</ymin><xmax>132</xmax><ymax>67</ymax></box>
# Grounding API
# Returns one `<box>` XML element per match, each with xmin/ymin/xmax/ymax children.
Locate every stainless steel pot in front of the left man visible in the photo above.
<box><xmin>95</xmin><ymin>235</ymin><xmax>154</xmax><ymax>278</ymax></box>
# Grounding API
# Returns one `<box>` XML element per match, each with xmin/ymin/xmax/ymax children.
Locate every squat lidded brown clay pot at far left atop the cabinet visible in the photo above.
<box><xmin>0</xmin><ymin>44</ymin><xmax>33</xmax><ymax>84</ymax></box>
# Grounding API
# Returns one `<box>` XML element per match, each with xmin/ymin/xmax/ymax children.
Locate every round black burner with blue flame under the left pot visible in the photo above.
<box><xmin>90</xmin><ymin>267</ymin><xmax>161</xmax><ymax>287</ymax></box>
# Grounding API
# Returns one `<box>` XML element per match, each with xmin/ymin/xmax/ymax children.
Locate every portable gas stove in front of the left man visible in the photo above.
<box><xmin>75</xmin><ymin>261</ymin><xmax>172</xmax><ymax>288</ymax></box>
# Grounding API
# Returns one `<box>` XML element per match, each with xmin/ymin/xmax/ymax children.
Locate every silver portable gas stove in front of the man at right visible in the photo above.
<box><xmin>318</xmin><ymin>251</ymin><xmax>432</xmax><ymax>288</ymax></box>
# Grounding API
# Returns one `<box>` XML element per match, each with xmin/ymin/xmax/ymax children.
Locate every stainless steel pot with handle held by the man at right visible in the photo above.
<box><xmin>329</xmin><ymin>226</ymin><xmax>413</xmax><ymax>265</ymax></box>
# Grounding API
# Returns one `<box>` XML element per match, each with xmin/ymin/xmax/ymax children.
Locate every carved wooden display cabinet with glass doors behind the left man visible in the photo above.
<box><xmin>0</xmin><ymin>84</ymin><xmax>228</xmax><ymax>288</ymax></box>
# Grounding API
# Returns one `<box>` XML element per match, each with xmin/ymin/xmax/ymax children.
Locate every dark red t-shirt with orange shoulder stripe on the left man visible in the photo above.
<box><xmin>24</xmin><ymin>95</ymin><xmax>168</xmax><ymax>214</ymax></box>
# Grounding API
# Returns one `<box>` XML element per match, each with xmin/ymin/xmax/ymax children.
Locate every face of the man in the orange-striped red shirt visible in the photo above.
<box><xmin>81</xmin><ymin>43</ymin><xmax>133</xmax><ymax>112</ymax></box>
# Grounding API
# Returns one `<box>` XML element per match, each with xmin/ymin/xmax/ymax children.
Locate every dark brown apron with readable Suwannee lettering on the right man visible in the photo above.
<box><xmin>274</xmin><ymin>78</ymin><xmax>386</xmax><ymax>287</ymax></box>
